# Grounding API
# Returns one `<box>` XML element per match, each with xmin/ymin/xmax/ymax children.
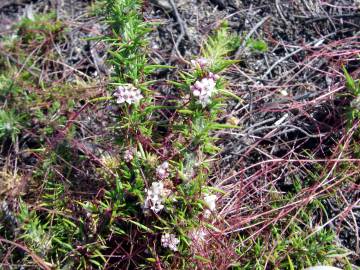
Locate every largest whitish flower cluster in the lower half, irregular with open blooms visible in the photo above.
<box><xmin>144</xmin><ymin>181</ymin><xmax>171</xmax><ymax>213</ymax></box>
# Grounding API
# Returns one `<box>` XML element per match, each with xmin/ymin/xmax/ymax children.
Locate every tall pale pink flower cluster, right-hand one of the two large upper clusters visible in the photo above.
<box><xmin>190</xmin><ymin>72</ymin><xmax>219</xmax><ymax>107</ymax></box>
